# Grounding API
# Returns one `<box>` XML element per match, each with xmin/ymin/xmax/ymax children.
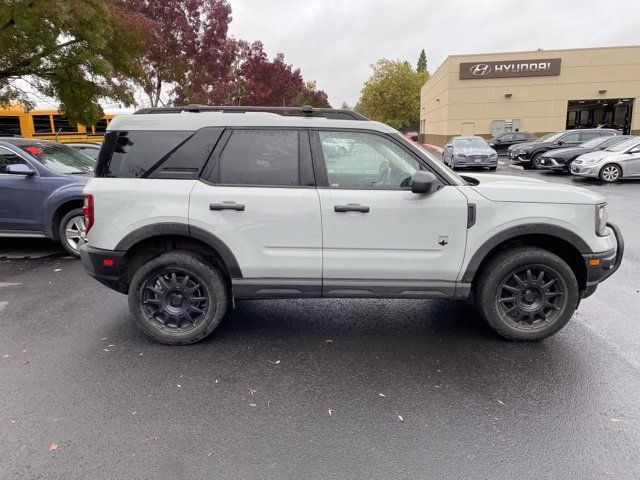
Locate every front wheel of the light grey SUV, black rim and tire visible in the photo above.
<box><xmin>474</xmin><ymin>247</ymin><xmax>580</xmax><ymax>341</ymax></box>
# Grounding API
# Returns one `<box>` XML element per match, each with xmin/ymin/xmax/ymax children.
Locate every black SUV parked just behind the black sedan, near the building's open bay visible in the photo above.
<box><xmin>508</xmin><ymin>128</ymin><xmax>620</xmax><ymax>169</ymax></box>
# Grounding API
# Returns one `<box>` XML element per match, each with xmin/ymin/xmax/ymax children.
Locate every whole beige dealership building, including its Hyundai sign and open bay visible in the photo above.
<box><xmin>420</xmin><ymin>46</ymin><xmax>640</xmax><ymax>146</ymax></box>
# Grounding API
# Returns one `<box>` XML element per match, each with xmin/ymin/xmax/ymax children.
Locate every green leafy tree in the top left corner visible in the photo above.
<box><xmin>0</xmin><ymin>0</ymin><xmax>147</xmax><ymax>125</ymax></box>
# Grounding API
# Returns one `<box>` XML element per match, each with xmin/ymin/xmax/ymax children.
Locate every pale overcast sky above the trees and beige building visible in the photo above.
<box><xmin>228</xmin><ymin>0</ymin><xmax>640</xmax><ymax>107</ymax></box>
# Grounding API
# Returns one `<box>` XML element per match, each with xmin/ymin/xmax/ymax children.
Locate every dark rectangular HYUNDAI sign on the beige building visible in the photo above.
<box><xmin>460</xmin><ymin>58</ymin><xmax>560</xmax><ymax>80</ymax></box>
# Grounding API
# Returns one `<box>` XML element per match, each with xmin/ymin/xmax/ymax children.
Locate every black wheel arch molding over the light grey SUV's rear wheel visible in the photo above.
<box><xmin>115</xmin><ymin>222</ymin><xmax>242</xmax><ymax>278</ymax></box>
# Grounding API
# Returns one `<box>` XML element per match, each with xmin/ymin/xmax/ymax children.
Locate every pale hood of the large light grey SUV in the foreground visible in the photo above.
<box><xmin>466</xmin><ymin>174</ymin><xmax>605</xmax><ymax>205</ymax></box>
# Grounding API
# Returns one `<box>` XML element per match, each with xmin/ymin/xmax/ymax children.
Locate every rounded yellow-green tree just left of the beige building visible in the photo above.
<box><xmin>355</xmin><ymin>59</ymin><xmax>429</xmax><ymax>131</ymax></box>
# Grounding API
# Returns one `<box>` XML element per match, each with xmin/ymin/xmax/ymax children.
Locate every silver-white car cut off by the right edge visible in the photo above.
<box><xmin>571</xmin><ymin>137</ymin><xmax>640</xmax><ymax>183</ymax></box>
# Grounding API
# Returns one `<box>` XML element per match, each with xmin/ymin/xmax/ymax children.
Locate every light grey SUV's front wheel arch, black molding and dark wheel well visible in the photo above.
<box><xmin>462</xmin><ymin>224</ymin><xmax>593</xmax><ymax>291</ymax></box>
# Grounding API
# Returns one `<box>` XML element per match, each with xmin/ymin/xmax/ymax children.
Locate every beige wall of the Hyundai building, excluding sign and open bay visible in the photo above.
<box><xmin>420</xmin><ymin>46</ymin><xmax>640</xmax><ymax>146</ymax></box>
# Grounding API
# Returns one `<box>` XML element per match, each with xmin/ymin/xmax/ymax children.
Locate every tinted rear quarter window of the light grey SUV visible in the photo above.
<box><xmin>96</xmin><ymin>128</ymin><xmax>223</xmax><ymax>179</ymax></box>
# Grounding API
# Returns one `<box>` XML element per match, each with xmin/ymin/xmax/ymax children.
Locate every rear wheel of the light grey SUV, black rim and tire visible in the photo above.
<box><xmin>129</xmin><ymin>251</ymin><xmax>229</xmax><ymax>345</ymax></box>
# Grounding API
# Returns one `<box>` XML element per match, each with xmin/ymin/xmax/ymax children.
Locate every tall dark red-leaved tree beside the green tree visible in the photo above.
<box><xmin>119</xmin><ymin>0</ymin><xmax>236</xmax><ymax>107</ymax></box>
